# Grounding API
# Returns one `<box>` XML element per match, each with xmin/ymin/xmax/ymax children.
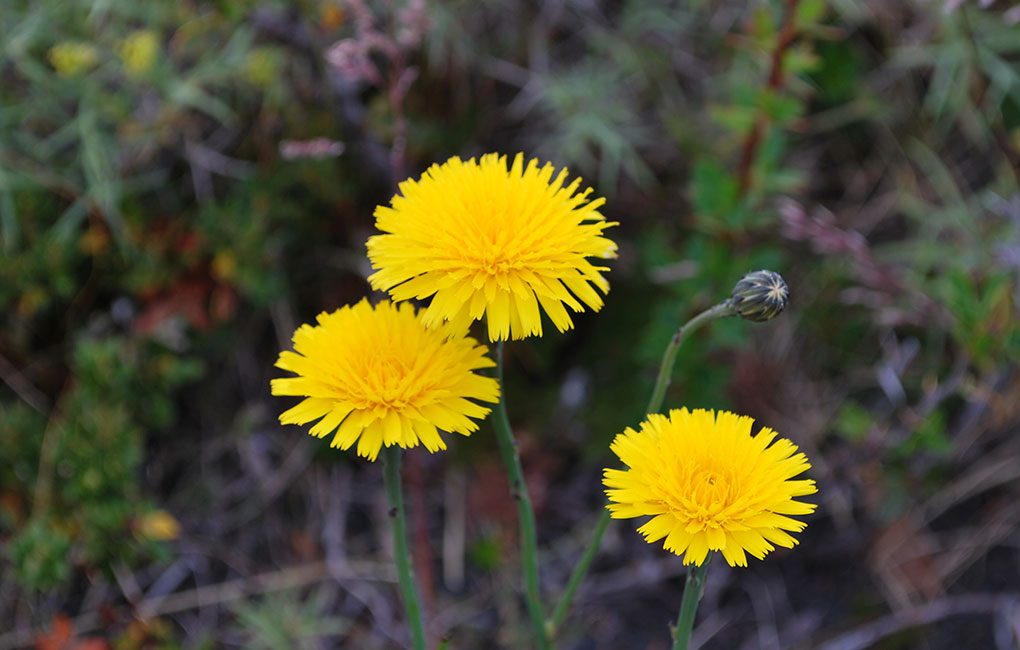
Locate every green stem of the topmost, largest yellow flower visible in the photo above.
<box><xmin>493</xmin><ymin>341</ymin><xmax>549</xmax><ymax>650</ymax></box>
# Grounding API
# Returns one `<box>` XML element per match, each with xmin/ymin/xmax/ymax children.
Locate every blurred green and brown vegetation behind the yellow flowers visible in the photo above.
<box><xmin>0</xmin><ymin>0</ymin><xmax>1020</xmax><ymax>648</ymax></box>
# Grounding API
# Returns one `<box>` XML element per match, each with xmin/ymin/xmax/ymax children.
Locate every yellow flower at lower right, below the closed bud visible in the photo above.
<box><xmin>603</xmin><ymin>408</ymin><xmax>817</xmax><ymax>566</ymax></box>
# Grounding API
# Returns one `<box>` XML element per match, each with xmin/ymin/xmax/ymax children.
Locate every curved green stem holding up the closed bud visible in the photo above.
<box><xmin>547</xmin><ymin>300</ymin><xmax>734</xmax><ymax>638</ymax></box>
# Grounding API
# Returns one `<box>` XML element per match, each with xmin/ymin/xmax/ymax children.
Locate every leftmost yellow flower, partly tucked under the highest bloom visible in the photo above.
<box><xmin>272</xmin><ymin>300</ymin><xmax>500</xmax><ymax>460</ymax></box>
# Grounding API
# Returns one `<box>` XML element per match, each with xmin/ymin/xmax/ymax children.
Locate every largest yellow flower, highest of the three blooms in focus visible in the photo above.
<box><xmin>368</xmin><ymin>153</ymin><xmax>616</xmax><ymax>341</ymax></box>
